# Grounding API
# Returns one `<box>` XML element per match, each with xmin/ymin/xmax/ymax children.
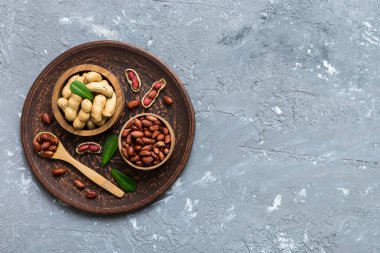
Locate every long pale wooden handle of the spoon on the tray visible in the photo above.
<box><xmin>65</xmin><ymin>157</ymin><xmax>124</xmax><ymax>198</ymax></box>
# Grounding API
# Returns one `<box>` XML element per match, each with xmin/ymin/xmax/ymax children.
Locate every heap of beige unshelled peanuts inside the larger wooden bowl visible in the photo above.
<box><xmin>57</xmin><ymin>71</ymin><xmax>117</xmax><ymax>130</ymax></box>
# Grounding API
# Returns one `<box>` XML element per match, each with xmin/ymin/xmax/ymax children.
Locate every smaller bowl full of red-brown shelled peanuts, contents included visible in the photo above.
<box><xmin>119</xmin><ymin>113</ymin><xmax>175</xmax><ymax>170</ymax></box>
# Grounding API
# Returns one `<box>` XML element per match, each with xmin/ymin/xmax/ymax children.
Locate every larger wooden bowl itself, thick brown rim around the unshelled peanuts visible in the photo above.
<box><xmin>51</xmin><ymin>64</ymin><xmax>125</xmax><ymax>136</ymax></box>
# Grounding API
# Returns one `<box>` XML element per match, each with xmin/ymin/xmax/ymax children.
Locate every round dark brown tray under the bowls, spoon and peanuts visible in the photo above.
<box><xmin>21</xmin><ymin>41</ymin><xmax>195</xmax><ymax>214</ymax></box>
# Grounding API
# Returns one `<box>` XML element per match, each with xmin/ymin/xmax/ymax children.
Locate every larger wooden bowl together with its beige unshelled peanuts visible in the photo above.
<box><xmin>51</xmin><ymin>64</ymin><xmax>125</xmax><ymax>136</ymax></box>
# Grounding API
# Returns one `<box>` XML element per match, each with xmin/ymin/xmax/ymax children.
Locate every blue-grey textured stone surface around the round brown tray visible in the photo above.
<box><xmin>0</xmin><ymin>0</ymin><xmax>380</xmax><ymax>253</ymax></box>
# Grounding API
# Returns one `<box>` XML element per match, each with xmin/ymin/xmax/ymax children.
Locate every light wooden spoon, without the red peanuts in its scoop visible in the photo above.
<box><xmin>34</xmin><ymin>132</ymin><xmax>124</xmax><ymax>198</ymax></box>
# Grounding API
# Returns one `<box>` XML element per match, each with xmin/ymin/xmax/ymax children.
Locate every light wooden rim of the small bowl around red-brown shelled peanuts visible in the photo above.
<box><xmin>119</xmin><ymin>113</ymin><xmax>175</xmax><ymax>170</ymax></box>
